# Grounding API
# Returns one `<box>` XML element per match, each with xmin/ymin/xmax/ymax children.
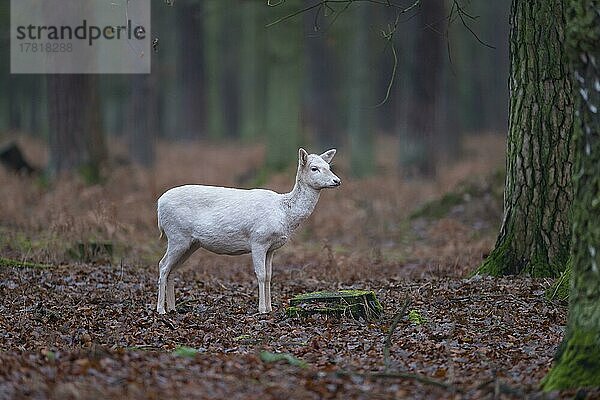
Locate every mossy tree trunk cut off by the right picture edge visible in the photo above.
<box><xmin>543</xmin><ymin>0</ymin><xmax>600</xmax><ymax>390</ymax></box>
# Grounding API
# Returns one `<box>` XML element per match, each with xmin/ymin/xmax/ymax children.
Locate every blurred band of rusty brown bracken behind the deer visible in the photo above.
<box><xmin>0</xmin><ymin>136</ymin><xmax>503</xmax><ymax>279</ymax></box>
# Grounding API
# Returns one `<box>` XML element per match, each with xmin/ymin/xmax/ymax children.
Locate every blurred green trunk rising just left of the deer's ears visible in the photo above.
<box><xmin>266</xmin><ymin>0</ymin><xmax>303</xmax><ymax>170</ymax></box>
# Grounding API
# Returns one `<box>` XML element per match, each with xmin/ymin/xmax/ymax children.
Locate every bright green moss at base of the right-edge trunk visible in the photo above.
<box><xmin>541</xmin><ymin>331</ymin><xmax>600</xmax><ymax>391</ymax></box>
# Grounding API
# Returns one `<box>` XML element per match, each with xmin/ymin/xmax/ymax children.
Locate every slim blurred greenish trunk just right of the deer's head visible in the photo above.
<box><xmin>347</xmin><ymin>4</ymin><xmax>375</xmax><ymax>177</ymax></box>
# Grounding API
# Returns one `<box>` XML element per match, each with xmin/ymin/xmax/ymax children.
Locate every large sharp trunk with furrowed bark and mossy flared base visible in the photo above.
<box><xmin>477</xmin><ymin>0</ymin><xmax>573</xmax><ymax>276</ymax></box>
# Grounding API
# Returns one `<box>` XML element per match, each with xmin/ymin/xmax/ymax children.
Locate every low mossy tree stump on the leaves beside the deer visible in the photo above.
<box><xmin>286</xmin><ymin>290</ymin><xmax>383</xmax><ymax>320</ymax></box>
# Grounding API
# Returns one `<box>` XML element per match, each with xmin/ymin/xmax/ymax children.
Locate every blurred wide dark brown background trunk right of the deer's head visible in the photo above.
<box><xmin>400</xmin><ymin>1</ymin><xmax>446</xmax><ymax>178</ymax></box>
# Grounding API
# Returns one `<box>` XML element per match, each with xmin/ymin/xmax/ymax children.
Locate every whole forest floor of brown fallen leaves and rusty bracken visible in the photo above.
<box><xmin>0</xmin><ymin>136</ymin><xmax>584</xmax><ymax>399</ymax></box>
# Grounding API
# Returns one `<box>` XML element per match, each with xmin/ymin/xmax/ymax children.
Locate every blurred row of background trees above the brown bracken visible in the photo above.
<box><xmin>0</xmin><ymin>0</ymin><xmax>509</xmax><ymax>178</ymax></box>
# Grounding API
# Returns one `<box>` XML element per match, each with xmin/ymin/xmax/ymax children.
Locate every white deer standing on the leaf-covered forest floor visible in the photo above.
<box><xmin>156</xmin><ymin>149</ymin><xmax>341</xmax><ymax>314</ymax></box>
